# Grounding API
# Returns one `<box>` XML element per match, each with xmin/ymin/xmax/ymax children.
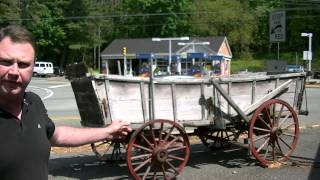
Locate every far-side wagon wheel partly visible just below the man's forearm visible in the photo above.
<box><xmin>91</xmin><ymin>141</ymin><xmax>126</xmax><ymax>161</ymax></box>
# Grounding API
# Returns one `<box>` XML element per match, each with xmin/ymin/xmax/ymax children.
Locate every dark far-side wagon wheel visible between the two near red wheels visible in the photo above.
<box><xmin>196</xmin><ymin>127</ymin><xmax>240</xmax><ymax>150</ymax></box>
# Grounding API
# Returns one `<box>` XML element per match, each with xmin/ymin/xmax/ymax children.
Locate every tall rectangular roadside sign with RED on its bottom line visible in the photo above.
<box><xmin>269</xmin><ymin>11</ymin><xmax>286</xmax><ymax>42</ymax></box>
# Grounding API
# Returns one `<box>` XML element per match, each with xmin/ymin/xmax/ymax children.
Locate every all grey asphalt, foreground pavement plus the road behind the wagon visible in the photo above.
<box><xmin>29</xmin><ymin>78</ymin><xmax>320</xmax><ymax>180</ymax></box>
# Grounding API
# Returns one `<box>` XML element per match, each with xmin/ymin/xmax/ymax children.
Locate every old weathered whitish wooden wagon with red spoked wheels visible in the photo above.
<box><xmin>71</xmin><ymin>73</ymin><xmax>307</xmax><ymax>179</ymax></box>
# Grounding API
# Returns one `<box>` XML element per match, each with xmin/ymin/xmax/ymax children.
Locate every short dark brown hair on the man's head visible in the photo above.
<box><xmin>0</xmin><ymin>25</ymin><xmax>36</xmax><ymax>51</ymax></box>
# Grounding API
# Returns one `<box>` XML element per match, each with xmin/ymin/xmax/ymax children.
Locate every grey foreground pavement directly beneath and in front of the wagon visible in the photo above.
<box><xmin>49</xmin><ymin>128</ymin><xmax>320</xmax><ymax>180</ymax></box>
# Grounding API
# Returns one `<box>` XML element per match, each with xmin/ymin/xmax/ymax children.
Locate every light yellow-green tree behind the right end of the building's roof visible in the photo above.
<box><xmin>190</xmin><ymin>0</ymin><xmax>257</xmax><ymax>57</ymax></box>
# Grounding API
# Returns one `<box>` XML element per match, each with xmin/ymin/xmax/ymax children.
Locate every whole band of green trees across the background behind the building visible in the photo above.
<box><xmin>0</xmin><ymin>0</ymin><xmax>320</xmax><ymax>71</ymax></box>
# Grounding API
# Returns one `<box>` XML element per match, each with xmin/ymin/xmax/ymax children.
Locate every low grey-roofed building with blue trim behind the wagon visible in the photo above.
<box><xmin>101</xmin><ymin>36</ymin><xmax>232</xmax><ymax>76</ymax></box>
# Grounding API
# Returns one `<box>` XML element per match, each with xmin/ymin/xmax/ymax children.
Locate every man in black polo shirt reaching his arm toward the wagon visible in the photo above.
<box><xmin>0</xmin><ymin>25</ymin><xmax>131</xmax><ymax>180</ymax></box>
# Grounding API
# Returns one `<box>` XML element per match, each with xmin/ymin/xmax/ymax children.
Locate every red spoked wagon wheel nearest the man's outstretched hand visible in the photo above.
<box><xmin>127</xmin><ymin>119</ymin><xmax>190</xmax><ymax>179</ymax></box>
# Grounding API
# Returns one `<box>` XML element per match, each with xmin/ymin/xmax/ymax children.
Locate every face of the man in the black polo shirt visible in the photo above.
<box><xmin>0</xmin><ymin>37</ymin><xmax>35</xmax><ymax>99</ymax></box>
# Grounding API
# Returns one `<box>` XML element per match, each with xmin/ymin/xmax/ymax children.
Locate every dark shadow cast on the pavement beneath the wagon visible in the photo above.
<box><xmin>49</xmin><ymin>144</ymin><xmax>256</xmax><ymax>180</ymax></box>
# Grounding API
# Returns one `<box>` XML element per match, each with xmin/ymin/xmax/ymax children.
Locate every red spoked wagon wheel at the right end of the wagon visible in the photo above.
<box><xmin>249</xmin><ymin>99</ymin><xmax>299</xmax><ymax>166</ymax></box>
